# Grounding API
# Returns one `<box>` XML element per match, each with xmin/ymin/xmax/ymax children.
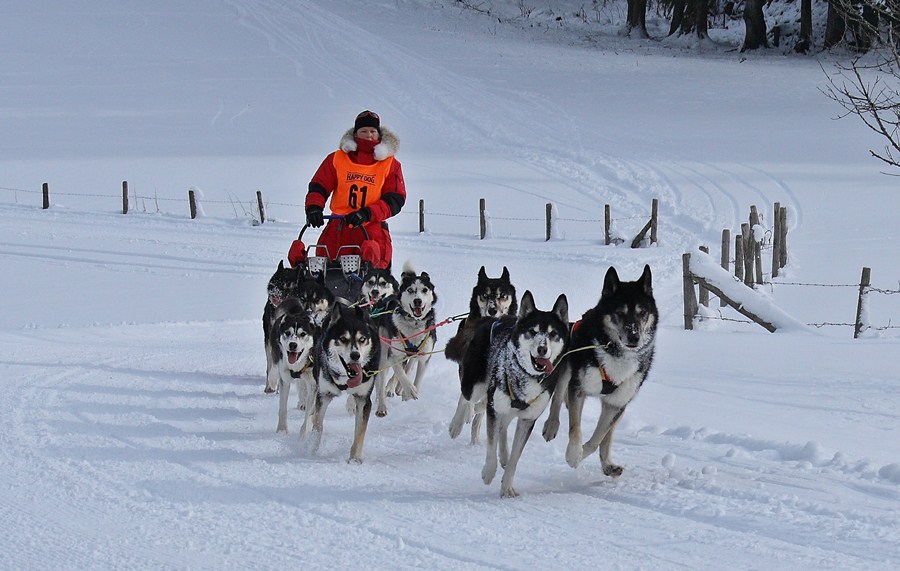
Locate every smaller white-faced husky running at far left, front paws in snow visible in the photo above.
<box><xmin>268</xmin><ymin>297</ymin><xmax>316</xmax><ymax>432</ymax></box>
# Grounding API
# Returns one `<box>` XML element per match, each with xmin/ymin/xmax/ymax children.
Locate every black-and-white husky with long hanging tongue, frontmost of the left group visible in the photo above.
<box><xmin>300</xmin><ymin>303</ymin><xmax>381</xmax><ymax>464</ymax></box>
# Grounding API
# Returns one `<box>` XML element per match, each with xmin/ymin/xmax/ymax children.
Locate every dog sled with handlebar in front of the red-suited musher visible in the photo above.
<box><xmin>288</xmin><ymin>215</ymin><xmax>380</xmax><ymax>305</ymax></box>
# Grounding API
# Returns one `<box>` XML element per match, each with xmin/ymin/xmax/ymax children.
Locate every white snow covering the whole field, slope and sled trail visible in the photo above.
<box><xmin>0</xmin><ymin>0</ymin><xmax>900</xmax><ymax>570</ymax></box>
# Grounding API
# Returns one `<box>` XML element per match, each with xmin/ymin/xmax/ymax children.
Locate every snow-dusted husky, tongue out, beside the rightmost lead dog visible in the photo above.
<box><xmin>462</xmin><ymin>291</ymin><xmax>569</xmax><ymax>498</ymax></box>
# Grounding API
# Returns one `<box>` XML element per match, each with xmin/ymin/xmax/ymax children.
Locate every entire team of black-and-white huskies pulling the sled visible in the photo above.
<box><xmin>263</xmin><ymin>262</ymin><xmax>659</xmax><ymax>497</ymax></box>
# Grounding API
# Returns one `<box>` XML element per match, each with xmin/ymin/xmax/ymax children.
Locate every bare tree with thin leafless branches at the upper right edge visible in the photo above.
<box><xmin>823</xmin><ymin>0</ymin><xmax>900</xmax><ymax>171</ymax></box>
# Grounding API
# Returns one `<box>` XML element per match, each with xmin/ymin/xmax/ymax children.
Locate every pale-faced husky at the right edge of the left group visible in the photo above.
<box><xmin>375</xmin><ymin>260</ymin><xmax>437</xmax><ymax>417</ymax></box>
